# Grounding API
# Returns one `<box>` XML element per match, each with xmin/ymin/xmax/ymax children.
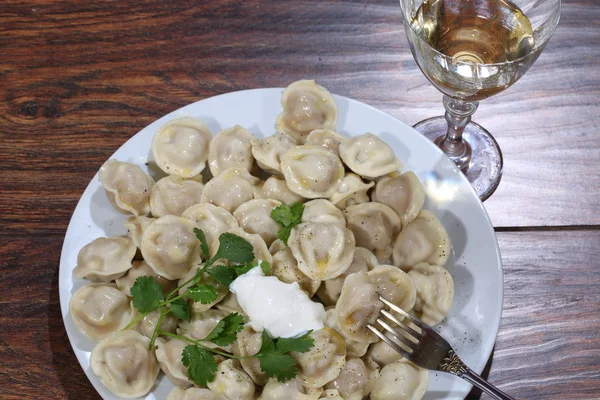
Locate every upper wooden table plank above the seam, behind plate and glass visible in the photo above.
<box><xmin>0</xmin><ymin>0</ymin><xmax>600</xmax><ymax>233</ymax></box>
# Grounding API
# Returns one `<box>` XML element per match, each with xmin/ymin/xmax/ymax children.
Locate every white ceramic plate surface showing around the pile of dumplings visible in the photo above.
<box><xmin>59</xmin><ymin>89</ymin><xmax>503</xmax><ymax>400</ymax></box>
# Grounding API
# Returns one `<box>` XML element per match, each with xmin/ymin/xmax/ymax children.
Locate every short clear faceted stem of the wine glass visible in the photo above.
<box><xmin>435</xmin><ymin>96</ymin><xmax>479</xmax><ymax>173</ymax></box>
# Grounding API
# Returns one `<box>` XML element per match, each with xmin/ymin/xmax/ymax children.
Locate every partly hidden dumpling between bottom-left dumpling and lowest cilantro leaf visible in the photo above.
<box><xmin>155</xmin><ymin>337</ymin><xmax>192</xmax><ymax>387</ymax></box>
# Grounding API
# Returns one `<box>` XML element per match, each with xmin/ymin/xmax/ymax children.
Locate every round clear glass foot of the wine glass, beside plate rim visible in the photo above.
<box><xmin>414</xmin><ymin>117</ymin><xmax>502</xmax><ymax>201</ymax></box>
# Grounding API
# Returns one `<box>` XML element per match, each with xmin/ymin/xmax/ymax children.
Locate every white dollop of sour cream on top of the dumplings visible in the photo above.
<box><xmin>229</xmin><ymin>264</ymin><xmax>325</xmax><ymax>338</ymax></box>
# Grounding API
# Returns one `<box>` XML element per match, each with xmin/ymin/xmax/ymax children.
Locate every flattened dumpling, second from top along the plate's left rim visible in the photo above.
<box><xmin>73</xmin><ymin>236</ymin><xmax>137</xmax><ymax>282</ymax></box>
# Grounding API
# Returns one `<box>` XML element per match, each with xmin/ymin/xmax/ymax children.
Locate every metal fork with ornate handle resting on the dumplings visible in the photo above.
<box><xmin>367</xmin><ymin>296</ymin><xmax>515</xmax><ymax>400</ymax></box>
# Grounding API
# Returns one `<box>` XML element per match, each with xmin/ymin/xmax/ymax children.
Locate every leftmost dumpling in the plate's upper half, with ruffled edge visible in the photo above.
<box><xmin>98</xmin><ymin>160</ymin><xmax>154</xmax><ymax>216</ymax></box>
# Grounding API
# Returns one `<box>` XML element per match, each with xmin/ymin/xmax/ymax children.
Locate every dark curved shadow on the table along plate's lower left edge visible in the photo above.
<box><xmin>47</xmin><ymin>266</ymin><xmax>100</xmax><ymax>400</ymax></box>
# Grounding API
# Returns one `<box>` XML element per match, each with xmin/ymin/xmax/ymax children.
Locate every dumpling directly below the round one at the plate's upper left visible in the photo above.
<box><xmin>150</xmin><ymin>176</ymin><xmax>204</xmax><ymax>218</ymax></box>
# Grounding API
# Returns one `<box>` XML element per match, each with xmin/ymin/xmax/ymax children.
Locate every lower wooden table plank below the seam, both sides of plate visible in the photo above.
<box><xmin>0</xmin><ymin>231</ymin><xmax>600</xmax><ymax>400</ymax></box>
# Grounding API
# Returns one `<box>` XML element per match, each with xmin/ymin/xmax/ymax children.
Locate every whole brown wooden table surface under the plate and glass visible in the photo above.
<box><xmin>0</xmin><ymin>0</ymin><xmax>600</xmax><ymax>400</ymax></box>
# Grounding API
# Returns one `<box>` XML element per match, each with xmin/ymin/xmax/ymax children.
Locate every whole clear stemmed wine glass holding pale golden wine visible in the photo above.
<box><xmin>400</xmin><ymin>0</ymin><xmax>561</xmax><ymax>201</ymax></box>
